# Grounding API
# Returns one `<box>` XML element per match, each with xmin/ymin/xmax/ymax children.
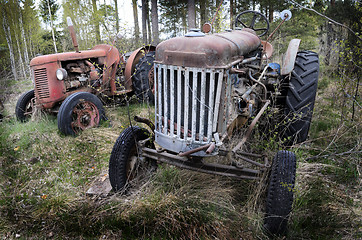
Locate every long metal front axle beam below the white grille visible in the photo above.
<box><xmin>141</xmin><ymin>147</ymin><xmax>262</xmax><ymax>179</ymax></box>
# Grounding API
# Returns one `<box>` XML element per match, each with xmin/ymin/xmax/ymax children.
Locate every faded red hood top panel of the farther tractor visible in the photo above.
<box><xmin>30</xmin><ymin>44</ymin><xmax>118</xmax><ymax>66</ymax></box>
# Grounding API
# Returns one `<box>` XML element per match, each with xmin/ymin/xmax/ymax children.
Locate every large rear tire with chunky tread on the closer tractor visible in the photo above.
<box><xmin>283</xmin><ymin>51</ymin><xmax>319</xmax><ymax>146</ymax></box>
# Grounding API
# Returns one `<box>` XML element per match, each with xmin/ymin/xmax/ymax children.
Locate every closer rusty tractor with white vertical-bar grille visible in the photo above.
<box><xmin>109</xmin><ymin>10</ymin><xmax>319</xmax><ymax>234</ymax></box>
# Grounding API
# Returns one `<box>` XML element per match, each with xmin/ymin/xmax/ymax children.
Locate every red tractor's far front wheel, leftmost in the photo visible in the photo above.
<box><xmin>15</xmin><ymin>89</ymin><xmax>35</xmax><ymax>122</ymax></box>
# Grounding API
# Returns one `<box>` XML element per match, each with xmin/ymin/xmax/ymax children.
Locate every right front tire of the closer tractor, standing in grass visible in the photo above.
<box><xmin>264</xmin><ymin>151</ymin><xmax>296</xmax><ymax>235</ymax></box>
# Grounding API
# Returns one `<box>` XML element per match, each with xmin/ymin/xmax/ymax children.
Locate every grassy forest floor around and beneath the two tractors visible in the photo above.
<box><xmin>0</xmin><ymin>75</ymin><xmax>362</xmax><ymax>239</ymax></box>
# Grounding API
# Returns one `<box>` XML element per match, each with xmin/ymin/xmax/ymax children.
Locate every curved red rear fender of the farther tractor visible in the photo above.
<box><xmin>124</xmin><ymin>45</ymin><xmax>156</xmax><ymax>90</ymax></box>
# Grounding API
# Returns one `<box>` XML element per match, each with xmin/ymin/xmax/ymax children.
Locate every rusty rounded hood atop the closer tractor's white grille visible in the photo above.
<box><xmin>155</xmin><ymin>29</ymin><xmax>261</xmax><ymax>68</ymax></box>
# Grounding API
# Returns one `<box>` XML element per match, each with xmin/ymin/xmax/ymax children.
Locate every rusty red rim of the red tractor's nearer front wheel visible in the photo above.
<box><xmin>71</xmin><ymin>101</ymin><xmax>100</xmax><ymax>133</ymax></box>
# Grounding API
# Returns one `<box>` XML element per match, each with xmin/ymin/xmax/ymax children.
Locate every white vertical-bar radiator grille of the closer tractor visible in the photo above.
<box><xmin>155</xmin><ymin>64</ymin><xmax>223</xmax><ymax>152</ymax></box>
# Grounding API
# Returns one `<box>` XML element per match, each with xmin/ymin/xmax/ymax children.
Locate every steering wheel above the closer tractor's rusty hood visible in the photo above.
<box><xmin>235</xmin><ymin>10</ymin><xmax>269</xmax><ymax>37</ymax></box>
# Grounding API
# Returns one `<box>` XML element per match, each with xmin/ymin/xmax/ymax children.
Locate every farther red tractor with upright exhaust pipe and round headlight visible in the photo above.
<box><xmin>15</xmin><ymin>18</ymin><xmax>155</xmax><ymax>135</ymax></box>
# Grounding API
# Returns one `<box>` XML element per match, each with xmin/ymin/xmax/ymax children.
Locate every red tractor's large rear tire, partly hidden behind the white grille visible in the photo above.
<box><xmin>132</xmin><ymin>52</ymin><xmax>155</xmax><ymax>104</ymax></box>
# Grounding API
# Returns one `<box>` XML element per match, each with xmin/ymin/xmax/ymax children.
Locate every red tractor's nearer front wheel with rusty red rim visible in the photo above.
<box><xmin>58</xmin><ymin>92</ymin><xmax>105</xmax><ymax>136</ymax></box>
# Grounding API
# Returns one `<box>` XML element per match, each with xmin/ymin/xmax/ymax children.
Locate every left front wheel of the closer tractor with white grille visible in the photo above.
<box><xmin>109</xmin><ymin>126</ymin><xmax>157</xmax><ymax>191</ymax></box>
